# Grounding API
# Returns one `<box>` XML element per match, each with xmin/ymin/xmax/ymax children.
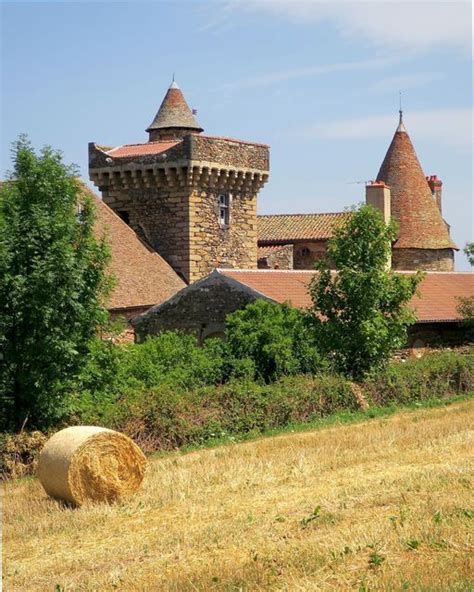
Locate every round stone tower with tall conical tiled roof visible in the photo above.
<box><xmin>377</xmin><ymin>111</ymin><xmax>457</xmax><ymax>271</ymax></box>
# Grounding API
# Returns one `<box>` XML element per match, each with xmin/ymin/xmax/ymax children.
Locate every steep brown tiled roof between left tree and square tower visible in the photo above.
<box><xmin>83</xmin><ymin>185</ymin><xmax>186</xmax><ymax>309</ymax></box>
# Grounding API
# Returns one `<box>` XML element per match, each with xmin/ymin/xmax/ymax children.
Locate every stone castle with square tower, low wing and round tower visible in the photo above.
<box><xmin>89</xmin><ymin>82</ymin><xmax>457</xmax><ymax>283</ymax></box>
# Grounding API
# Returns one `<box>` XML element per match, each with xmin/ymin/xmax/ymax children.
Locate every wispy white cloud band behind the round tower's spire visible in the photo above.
<box><xmin>301</xmin><ymin>109</ymin><xmax>472</xmax><ymax>148</ymax></box>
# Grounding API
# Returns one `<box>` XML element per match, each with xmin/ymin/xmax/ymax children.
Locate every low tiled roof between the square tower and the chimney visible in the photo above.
<box><xmin>257</xmin><ymin>212</ymin><xmax>351</xmax><ymax>243</ymax></box>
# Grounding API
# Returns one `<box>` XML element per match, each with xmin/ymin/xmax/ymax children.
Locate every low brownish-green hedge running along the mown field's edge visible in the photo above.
<box><xmin>75</xmin><ymin>336</ymin><xmax>474</xmax><ymax>451</ymax></box>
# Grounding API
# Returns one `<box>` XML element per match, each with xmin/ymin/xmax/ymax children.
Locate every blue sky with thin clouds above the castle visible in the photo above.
<box><xmin>0</xmin><ymin>0</ymin><xmax>474</xmax><ymax>271</ymax></box>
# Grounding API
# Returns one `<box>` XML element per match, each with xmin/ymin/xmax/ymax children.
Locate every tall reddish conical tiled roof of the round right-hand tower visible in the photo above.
<box><xmin>377</xmin><ymin>112</ymin><xmax>457</xmax><ymax>249</ymax></box>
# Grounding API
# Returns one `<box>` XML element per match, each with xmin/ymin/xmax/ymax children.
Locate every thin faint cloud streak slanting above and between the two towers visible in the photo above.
<box><xmin>223</xmin><ymin>58</ymin><xmax>395</xmax><ymax>90</ymax></box>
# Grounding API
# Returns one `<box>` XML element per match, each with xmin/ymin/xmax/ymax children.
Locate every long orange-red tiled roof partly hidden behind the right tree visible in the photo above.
<box><xmin>219</xmin><ymin>269</ymin><xmax>474</xmax><ymax>322</ymax></box>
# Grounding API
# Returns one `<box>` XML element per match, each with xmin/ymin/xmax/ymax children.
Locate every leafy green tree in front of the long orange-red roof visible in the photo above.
<box><xmin>310</xmin><ymin>206</ymin><xmax>423</xmax><ymax>380</ymax></box>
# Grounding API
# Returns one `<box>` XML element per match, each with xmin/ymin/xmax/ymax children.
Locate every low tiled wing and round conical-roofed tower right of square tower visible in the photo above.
<box><xmin>258</xmin><ymin>111</ymin><xmax>457</xmax><ymax>271</ymax></box>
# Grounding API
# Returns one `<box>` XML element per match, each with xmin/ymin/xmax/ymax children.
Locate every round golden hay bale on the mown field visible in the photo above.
<box><xmin>37</xmin><ymin>426</ymin><xmax>147</xmax><ymax>506</ymax></box>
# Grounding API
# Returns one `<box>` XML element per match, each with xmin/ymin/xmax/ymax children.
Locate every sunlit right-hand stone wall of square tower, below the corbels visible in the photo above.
<box><xmin>189</xmin><ymin>187</ymin><xmax>257</xmax><ymax>282</ymax></box>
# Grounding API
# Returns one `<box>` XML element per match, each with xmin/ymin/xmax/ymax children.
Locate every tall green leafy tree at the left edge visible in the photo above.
<box><xmin>0</xmin><ymin>136</ymin><xmax>111</xmax><ymax>428</ymax></box>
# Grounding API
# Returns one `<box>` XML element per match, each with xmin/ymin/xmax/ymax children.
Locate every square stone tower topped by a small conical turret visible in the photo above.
<box><xmin>89</xmin><ymin>81</ymin><xmax>269</xmax><ymax>282</ymax></box>
